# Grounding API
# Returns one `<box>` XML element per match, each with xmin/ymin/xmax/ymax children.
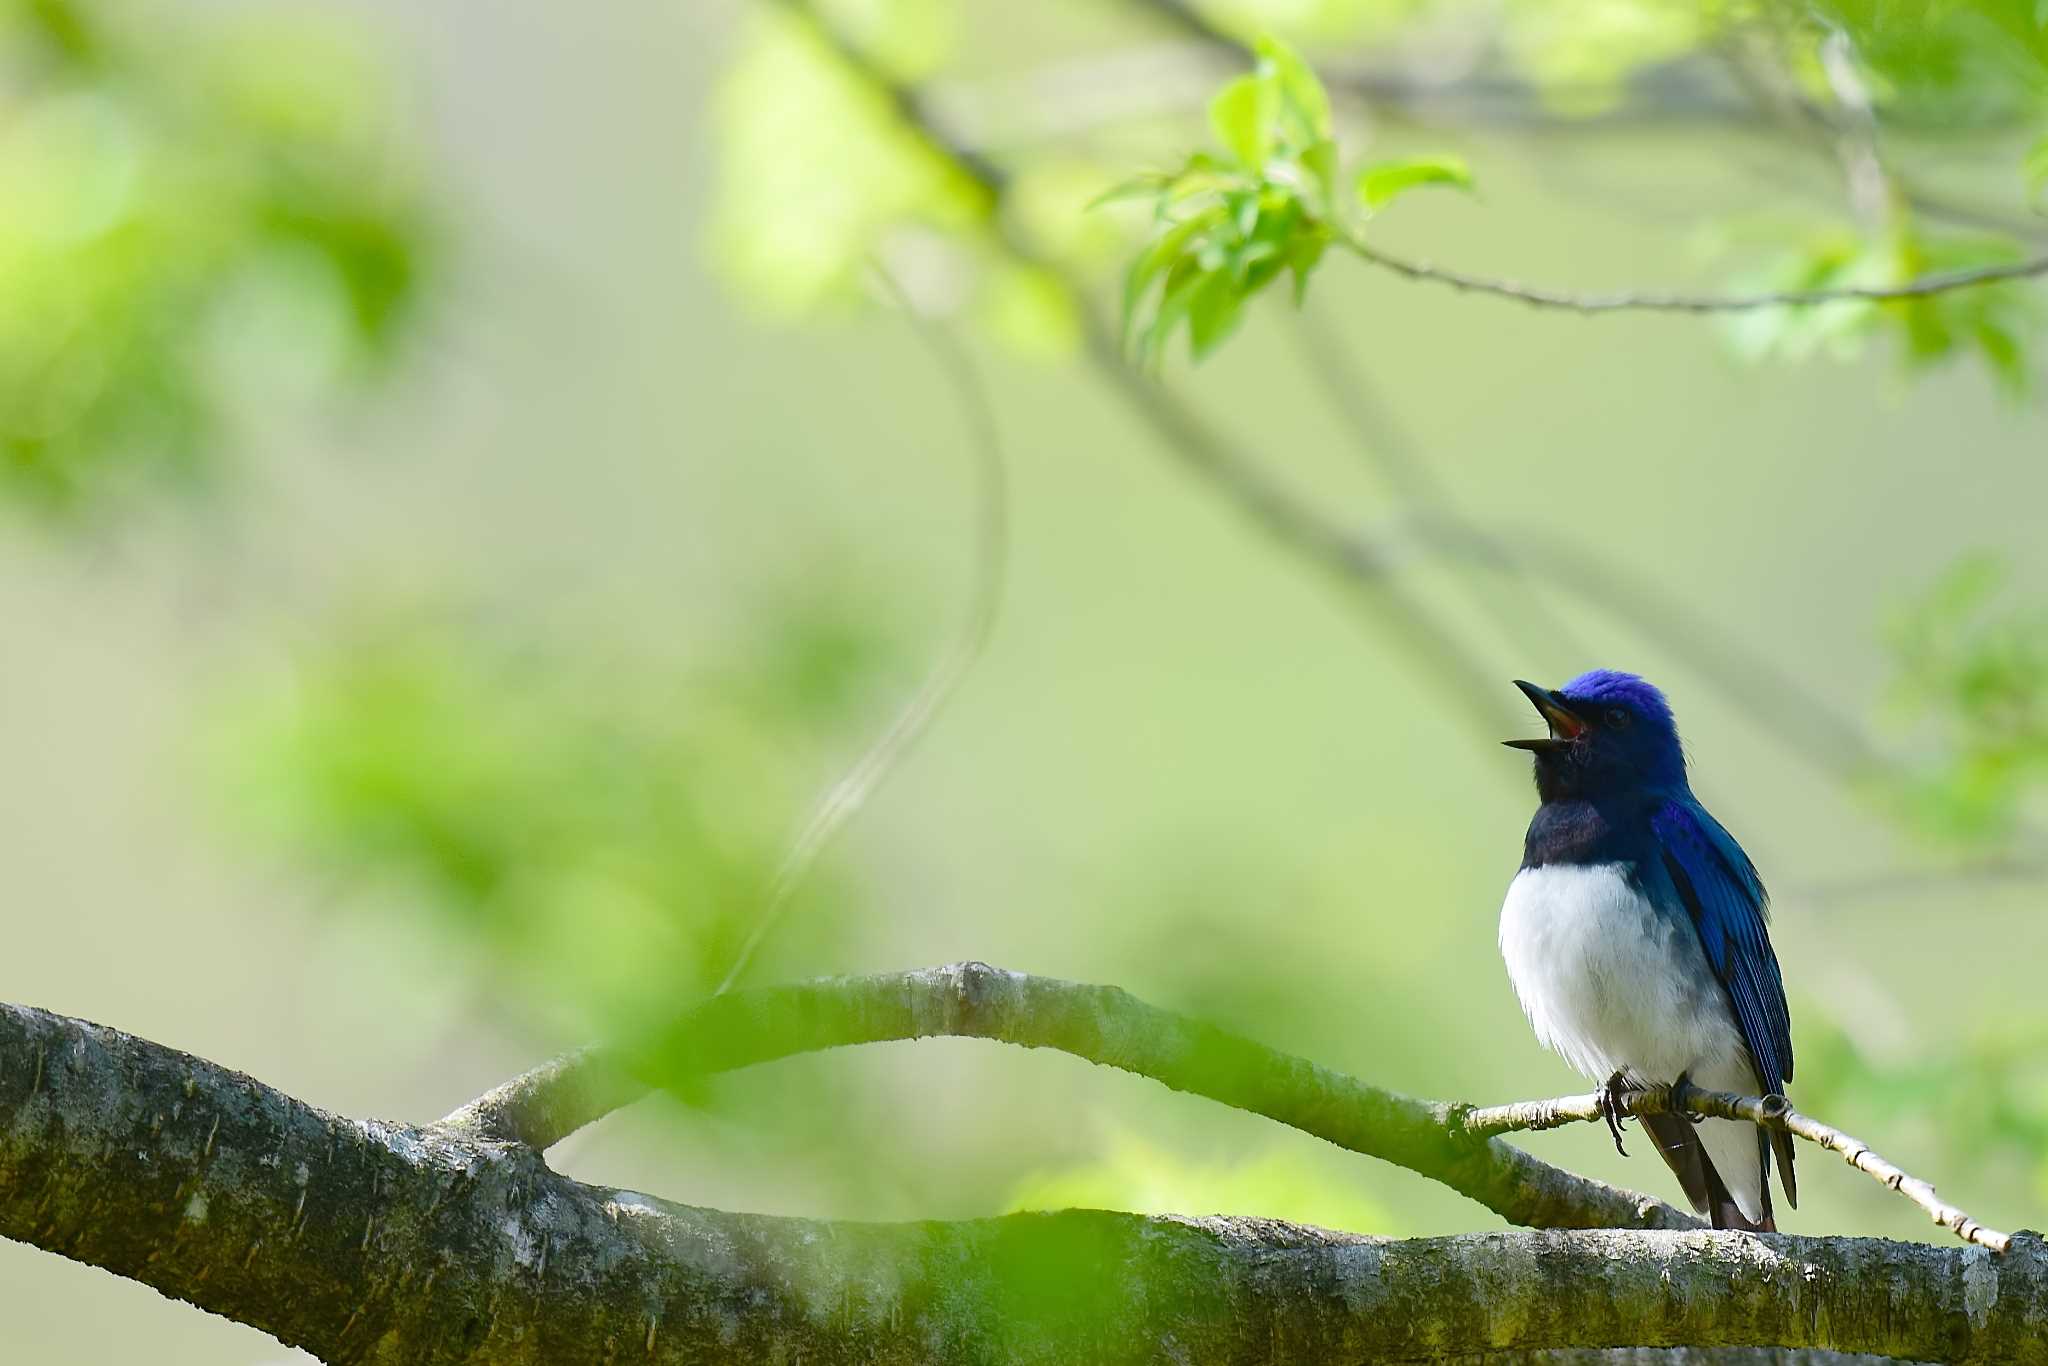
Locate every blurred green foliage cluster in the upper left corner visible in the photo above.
<box><xmin>0</xmin><ymin>0</ymin><xmax>426</xmax><ymax>514</ymax></box>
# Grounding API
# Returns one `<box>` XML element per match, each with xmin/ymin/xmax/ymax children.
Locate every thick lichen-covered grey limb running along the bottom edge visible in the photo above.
<box><xmin>0</xmin><ymin>993</ymin><xmax>2048</xmax><ymax>1366</ymax></box>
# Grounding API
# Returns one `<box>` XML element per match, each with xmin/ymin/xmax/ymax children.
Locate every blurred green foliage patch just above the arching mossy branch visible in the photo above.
<box><xmin>215</xmin><ymin>590</ymin><xmax>895</xmax><ymax>1038</ymax></box>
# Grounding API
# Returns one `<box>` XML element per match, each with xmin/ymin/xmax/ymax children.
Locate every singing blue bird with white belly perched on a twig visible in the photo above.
<box><xmin>1501</xmin><ymin>670</ymin><xmax>1798</xmax><ymax>1233</ymax></box>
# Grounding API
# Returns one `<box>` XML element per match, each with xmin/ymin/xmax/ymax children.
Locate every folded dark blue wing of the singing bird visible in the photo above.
<box><xmin>1651</xmin><ymin>795</ymin><xmax>1792</xmax><ymax>1092</ymax></box>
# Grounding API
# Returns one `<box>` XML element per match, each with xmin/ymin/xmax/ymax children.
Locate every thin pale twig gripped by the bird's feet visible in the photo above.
<box><xmin>1462</xmin><ymin>1085</ymin><xmax>2013</xmax><ymax>1251</ymax></box>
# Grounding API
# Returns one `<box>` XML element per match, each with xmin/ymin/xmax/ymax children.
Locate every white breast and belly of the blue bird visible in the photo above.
<box><xmin>1501</xmin><ymin>864</ymin><xmax>1763</xmax><ymax>1219</ymax></box>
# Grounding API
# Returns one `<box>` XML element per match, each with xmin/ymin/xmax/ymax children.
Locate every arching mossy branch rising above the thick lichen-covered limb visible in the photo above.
<box><xmin>442</xmin><ymin>963</ymin><xmax>1700</xmax><ymax>1229</ymax></box>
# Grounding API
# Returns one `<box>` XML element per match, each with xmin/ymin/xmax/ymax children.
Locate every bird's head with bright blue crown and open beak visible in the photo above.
<box><xmin>1503</xmin><ymin>670</ymin><xmax>1686</xmax><ymax>801</ymax></box>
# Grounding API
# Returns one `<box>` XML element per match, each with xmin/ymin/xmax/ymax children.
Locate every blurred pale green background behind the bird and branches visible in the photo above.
<box><xmin>0</xmin><ymin>0</ymin><xmax>2048</xmax><ymax>1364</ymax></box>
